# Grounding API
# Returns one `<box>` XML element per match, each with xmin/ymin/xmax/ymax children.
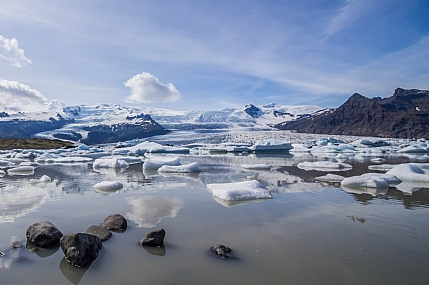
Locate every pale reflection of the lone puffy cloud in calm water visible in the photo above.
<box><xmin>125</xmin><ymin>197</ymin><xmax>183</xmax><ymax>228</ymax></box>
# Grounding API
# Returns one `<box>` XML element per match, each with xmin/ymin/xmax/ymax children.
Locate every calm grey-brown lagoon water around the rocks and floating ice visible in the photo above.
<box><xmin>0</xmin><ymin>132</ymin><xmax>429</xmax><ymax>284</ymax></box>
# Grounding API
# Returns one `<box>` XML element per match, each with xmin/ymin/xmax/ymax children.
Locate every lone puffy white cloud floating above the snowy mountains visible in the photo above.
<box><xmin>124</xmin><ymin>72</ymin><xmax>181</xmax><ymax>103</ymax></box>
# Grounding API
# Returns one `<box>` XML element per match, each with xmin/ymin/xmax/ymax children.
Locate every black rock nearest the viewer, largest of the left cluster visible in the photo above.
<box><xmin>60</xmin><ymin>233</ymin><xmax>102</xmax><ymax>267</ymax></box>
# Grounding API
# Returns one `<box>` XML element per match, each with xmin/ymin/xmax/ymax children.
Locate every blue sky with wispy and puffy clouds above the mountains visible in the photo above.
<box><xmin>0</xmin><ymin>0</ymin><xmax>429</xmax><ymax>110</ymax></box>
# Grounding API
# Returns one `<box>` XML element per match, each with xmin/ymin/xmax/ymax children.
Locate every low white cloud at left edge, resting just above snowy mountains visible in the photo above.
<box><xmin>0</xmin><ymin>78</ymin><xmax>48</xmax><ymax>107</ymax></box>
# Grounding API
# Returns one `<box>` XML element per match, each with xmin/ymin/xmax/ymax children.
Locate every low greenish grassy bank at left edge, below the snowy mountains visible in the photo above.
<box><xmin>0</xmin><ymin>138</ymin><xmax>73</xmax><ymax>150</ymax></box>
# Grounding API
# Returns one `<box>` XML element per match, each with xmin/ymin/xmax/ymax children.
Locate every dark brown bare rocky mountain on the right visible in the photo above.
<box><xmin>276</xmin><ymin>88</ymin><xmax>429</xmax><ymax>138</ymax></box>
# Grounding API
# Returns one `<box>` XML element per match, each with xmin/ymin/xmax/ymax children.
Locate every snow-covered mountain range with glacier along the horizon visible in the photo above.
<box><xmin>0</xmin><ymin>101</ymin><xmax>322</xmax><ymax>144</ymax></box>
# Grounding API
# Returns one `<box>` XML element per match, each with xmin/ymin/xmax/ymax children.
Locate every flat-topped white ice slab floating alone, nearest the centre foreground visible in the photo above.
<box><xmin>207</xmin><ymin>180</ymin><xmax>272</xmax><ymax>201</ymax></box>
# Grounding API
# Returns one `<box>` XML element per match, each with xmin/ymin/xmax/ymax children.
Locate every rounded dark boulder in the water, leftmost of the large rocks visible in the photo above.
<box><xmin>26</xmin><ymin>221</ymin><xmax>63</xmax><ymax>247</ymax></box>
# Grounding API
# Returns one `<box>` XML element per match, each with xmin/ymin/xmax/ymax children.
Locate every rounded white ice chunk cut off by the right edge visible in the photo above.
<box><xmin>386</xmin><ymin>163</ymin><xmax>429</xmax><ymax>182</ymax></box>
